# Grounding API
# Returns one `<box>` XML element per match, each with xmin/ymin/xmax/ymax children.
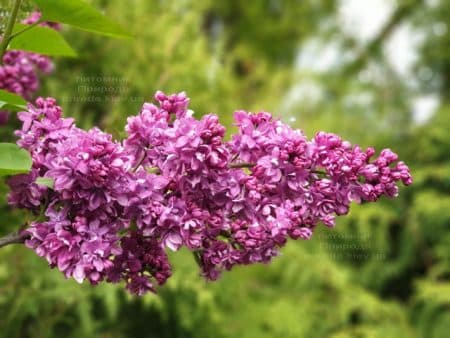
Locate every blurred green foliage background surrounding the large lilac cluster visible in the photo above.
<box><xmin>0</xmin><ymin>0</ymin><xmax>450</xmax><ymax>338</ymax></box>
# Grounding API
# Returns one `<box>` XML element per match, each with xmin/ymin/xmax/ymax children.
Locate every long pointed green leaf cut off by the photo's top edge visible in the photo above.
<box><xmin>33</xmin><ymin>0</ymin><xmax>131</xmax><ymax>38</ymax></box>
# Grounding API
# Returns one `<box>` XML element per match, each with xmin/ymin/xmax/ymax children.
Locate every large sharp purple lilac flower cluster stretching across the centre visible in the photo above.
<box><xmin>9</xmin><ymin>92</ymin><xmax>412</xmax><ymax>295</ymax></box>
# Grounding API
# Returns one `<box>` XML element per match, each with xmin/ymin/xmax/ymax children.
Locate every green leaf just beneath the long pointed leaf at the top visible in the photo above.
<box><xmin>8</xmin><ymin>23</ymin><xmax>77</xmax><ymax>56</ymax></box>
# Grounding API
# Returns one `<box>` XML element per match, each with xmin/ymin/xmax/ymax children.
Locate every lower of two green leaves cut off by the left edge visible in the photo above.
<box><xmin>0</xmin><ymin>143</ymin><xmax>32</xmax><ymax>176</ymax></box>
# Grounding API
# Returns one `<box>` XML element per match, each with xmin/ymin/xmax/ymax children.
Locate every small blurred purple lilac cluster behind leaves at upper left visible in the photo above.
<box><xmin>0</xmin><ymin>12</ymin><xmax>57</xmax><ymax>125</ymax></box>
